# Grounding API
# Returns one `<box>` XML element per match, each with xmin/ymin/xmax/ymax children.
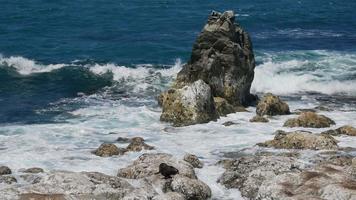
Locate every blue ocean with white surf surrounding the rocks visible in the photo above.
<box><xmin>0</xmin><ymin>0</ymin><xmax>356</xmax><ymax>199</ymax></box>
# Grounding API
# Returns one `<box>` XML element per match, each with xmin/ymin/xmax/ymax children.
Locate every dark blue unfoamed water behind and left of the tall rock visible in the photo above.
<box><xmin>0</xmin><ymin>0</ymin><xmax>356</xmax><ymax>123</ymax></box>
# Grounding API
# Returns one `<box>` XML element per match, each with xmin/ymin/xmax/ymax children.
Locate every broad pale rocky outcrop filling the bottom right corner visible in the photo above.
<box><xmin>219</xmin><ymin>149</ymin><xmax>356</xmax><ymax>200</ymax></box>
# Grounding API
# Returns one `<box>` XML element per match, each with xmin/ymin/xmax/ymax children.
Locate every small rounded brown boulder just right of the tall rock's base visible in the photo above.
<box><xmin>256</xmin><ymin>93</ymin><xmax>290</xmax><ymax>116</ymax></box>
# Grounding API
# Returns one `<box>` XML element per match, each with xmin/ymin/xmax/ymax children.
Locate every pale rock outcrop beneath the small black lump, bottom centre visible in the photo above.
<box><xmin>117</xmin><ymin>153</ymin><xmax>211</xmax><ymax>200</ymax></box>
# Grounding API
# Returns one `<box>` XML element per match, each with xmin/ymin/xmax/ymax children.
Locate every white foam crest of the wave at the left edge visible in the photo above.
<box><xmin>0</xmin><ymin>56</ymin><xmax>65</xmax><ymax>75</ymax></box>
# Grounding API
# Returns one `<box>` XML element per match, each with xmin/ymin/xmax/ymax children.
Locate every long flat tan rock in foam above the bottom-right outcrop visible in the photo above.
<box><xmin>258</xmin><ymin>131</ymin><xmax>338</xmax><ymax>150</ymax></box>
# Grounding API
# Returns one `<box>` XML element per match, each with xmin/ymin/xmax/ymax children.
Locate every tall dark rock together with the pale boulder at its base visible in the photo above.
<box><xmin>159</xmin><ymin>11</ymin><xmax>256</xmax><ymax>125</ymax></box>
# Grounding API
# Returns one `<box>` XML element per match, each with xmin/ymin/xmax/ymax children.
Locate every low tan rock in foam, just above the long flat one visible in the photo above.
<box><xmin>284</xmin><ymin>112</ymin><xmax>335</xmax><ymax>128</ymax></box>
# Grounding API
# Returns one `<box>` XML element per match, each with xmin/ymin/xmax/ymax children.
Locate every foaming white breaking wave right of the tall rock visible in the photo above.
<box><xmin>252</xmin><ymin>51</ymin><xmax>356</xmax><ymax>95</ymax></box>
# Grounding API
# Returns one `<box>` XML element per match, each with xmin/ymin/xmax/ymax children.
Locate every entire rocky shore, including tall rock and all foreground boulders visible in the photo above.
<box><xmin>0</xmin><ymin>11</ymin><xmax>356</xmax><ymax>200</ymax></box>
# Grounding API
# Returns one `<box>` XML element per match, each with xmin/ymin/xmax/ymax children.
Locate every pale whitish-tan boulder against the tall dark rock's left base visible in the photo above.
<box><xmin>160</xmin><ymin>80</ymin><xmax>218</xmax><ymax>126</ymax></box>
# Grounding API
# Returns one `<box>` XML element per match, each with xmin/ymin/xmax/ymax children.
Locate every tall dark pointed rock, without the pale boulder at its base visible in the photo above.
<box><xmin>174</xmin><ymin>11</ymin><xmax>256</xmax><ymax>105</ymax></box>
